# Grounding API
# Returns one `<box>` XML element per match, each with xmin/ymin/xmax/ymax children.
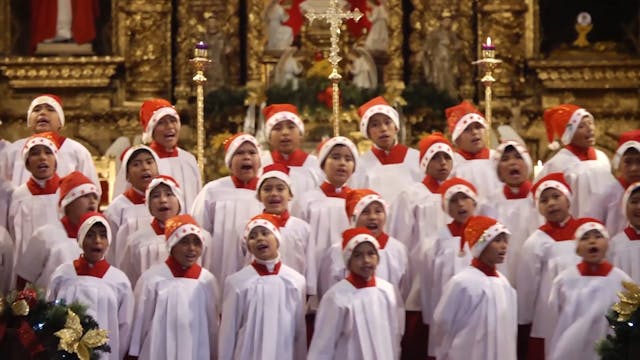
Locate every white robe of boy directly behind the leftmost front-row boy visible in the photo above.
<box><xmin>15</xmin><ymin>221</ymin><xmax>82</xmax><ymax>289</ymax></box>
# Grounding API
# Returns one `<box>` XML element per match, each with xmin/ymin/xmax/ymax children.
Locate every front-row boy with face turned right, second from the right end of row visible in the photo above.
<box><xmin>431</xmin><ymin>216</ymin><xmax>518</xmax><ymax>360</ymax></box>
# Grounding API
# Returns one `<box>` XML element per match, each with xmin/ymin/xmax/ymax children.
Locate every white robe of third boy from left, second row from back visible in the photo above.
<box><xmin>191</xmin><ymin>176</ymin><xmax>263</xmax><ymax>284</ymax></box>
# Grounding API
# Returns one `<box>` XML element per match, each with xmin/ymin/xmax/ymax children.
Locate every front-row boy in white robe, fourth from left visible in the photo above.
<box><xmin>307</xmin><ymin>228</ymin><xmax>404</xmax><ymax>360</ymax></box>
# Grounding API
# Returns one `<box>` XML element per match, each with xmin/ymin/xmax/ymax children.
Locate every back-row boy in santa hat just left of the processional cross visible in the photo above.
<box><xmin>262</xmin><ymin>104</ymin><xmax>322</xmax><ymax>194</ymax></box>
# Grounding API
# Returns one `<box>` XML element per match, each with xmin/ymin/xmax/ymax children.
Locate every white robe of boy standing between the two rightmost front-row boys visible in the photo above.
<box><xmin>516</xmin><ymin>230</ymin><xmax>581</xmax><ymax>340</ymax></box>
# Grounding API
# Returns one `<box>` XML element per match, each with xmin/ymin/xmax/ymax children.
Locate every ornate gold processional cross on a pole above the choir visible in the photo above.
<box><xmin>305</xmin><ymin>0</ymin><xmax>362</xmax><ymax>136</ymax></box>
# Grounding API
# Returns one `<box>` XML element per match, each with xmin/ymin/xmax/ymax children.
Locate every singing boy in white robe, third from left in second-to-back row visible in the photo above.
<box><xmin>191</xmin><ymin>133</ymin><xmax>262</xmax><ymax>283</ymax></box>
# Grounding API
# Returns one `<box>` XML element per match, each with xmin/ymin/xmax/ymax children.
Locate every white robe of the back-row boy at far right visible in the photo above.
<box><xmin>536</xmin><ymin>148</ymin><xmax>617</xmax><ymax>218</ymax></box>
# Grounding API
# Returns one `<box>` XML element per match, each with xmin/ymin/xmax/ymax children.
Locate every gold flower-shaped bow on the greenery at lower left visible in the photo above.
<box><xmin>54</xmin><ymin>310</ymin><xmax>109</xmax><ymax>360</ymax></box>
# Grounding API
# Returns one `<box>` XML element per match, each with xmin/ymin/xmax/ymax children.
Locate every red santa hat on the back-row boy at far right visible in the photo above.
<box><xmin>542</xmin><ymin>104</ymin><xmax>593</xmax><ymax>150</ymax></box>
